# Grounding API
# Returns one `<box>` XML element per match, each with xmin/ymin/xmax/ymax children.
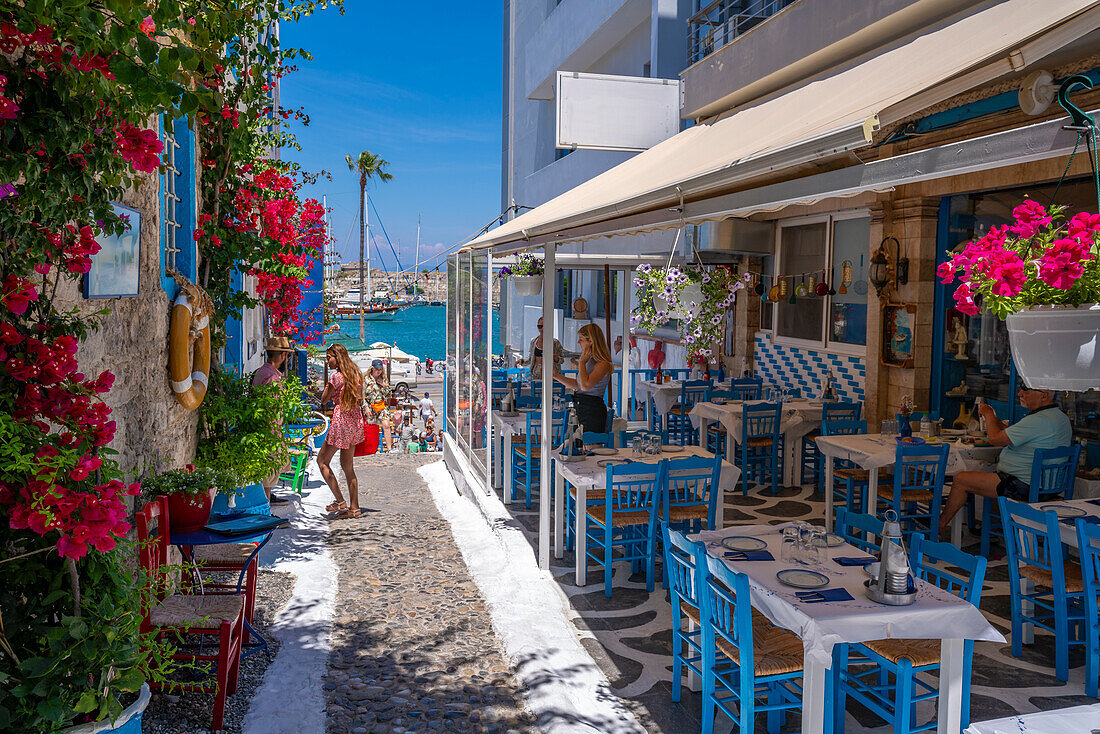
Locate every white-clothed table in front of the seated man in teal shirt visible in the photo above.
<box><xmin>816</xmin><ymin>434</ymin><xmax>1001</xmax><ymax>530</ymax></box>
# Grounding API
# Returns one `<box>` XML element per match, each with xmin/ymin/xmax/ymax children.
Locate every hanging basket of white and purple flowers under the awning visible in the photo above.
<box><xmin>630</xmin><ymin>264</ymin><xmax>748</xmax><ymax>360</ymax></box>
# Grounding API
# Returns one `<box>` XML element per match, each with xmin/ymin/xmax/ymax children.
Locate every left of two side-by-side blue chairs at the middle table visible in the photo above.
<box><xmin>578</xmin><ymin>461</ymin><xmax>668</xmax><ymax>599</ymax></box>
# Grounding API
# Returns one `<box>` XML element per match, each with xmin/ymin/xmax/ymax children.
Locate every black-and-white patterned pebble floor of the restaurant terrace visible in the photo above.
<box><xmin>509</xmin><ymin>485</ymin><xmax>1096</xmax><ymax>734</ymax></box>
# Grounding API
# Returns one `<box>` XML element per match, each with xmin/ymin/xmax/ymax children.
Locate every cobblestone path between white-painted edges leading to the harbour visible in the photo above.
<box><xmin>321</xmin><ymin>454</ymin><xmax>538</xmax><ymax>734</ymax></box>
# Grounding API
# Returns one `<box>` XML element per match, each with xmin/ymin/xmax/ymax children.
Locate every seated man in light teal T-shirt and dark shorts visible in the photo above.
<box><xmin>939</xmin><ymin>387</ymin><xmax>1074</xmax><ymax>535</ymax></box>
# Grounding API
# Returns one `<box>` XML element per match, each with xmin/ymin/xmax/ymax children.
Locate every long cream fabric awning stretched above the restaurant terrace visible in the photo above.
<box><xmin>466</xmin><ymin>0</ymin><xmax>1100</xmax><ymax>250</ymax></box>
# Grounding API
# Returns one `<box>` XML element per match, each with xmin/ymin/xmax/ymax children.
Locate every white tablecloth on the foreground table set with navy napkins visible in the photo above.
<box><xmin>696</xmin><ymin>523</ymin><xmax>1004</xmax><ymax>667</ymax></box>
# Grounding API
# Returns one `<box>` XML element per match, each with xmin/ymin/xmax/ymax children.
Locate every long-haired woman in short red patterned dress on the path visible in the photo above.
<box><xmin>317</xmin><ymin>344</ymin><xmax>363</xmax><ymax>519</ymax></box>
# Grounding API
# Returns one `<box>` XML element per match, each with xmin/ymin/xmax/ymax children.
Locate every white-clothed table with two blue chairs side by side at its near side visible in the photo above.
<box><xmin>553</xmin><ymin>446</ymin><xmax>741</xmax><ymax>587</ymax></box>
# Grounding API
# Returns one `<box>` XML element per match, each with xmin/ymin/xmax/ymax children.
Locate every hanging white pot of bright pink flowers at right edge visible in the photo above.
<box><xmin>938</xmin><ymin>200</ymin><xmax>1100</xmax><ymax>391</ymax></box>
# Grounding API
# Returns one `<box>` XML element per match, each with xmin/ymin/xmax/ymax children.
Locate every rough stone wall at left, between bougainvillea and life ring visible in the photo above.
<box><xmin>57</xmin><ymin>169</ymin><xmax>198</xmax><ymax>476</ymax></box>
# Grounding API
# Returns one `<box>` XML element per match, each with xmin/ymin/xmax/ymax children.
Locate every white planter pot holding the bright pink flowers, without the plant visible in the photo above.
<box><xmin>1004</xmin><ymin>304</ymin><xmax>1100</xmax><ymax>391</ymax></box>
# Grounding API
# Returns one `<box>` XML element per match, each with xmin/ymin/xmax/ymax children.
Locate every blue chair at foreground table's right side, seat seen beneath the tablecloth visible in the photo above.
<box><xmin>833</xmin><ymin>536</ymin><xmax>986</xmax><ymax>734</ymax></box>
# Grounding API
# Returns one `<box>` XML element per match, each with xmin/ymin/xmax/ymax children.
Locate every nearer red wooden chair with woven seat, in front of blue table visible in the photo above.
<box><xmin>136</xmin><ymin>497</ymin><xmax>244</xmax><ymax>731</ymax></box>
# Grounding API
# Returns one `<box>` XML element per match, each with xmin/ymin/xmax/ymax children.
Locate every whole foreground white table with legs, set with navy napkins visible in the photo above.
<box><xmin>694</xmin><ymin>524</ymin><xmax>1004</xmax><ymax>734</ymax></box>
